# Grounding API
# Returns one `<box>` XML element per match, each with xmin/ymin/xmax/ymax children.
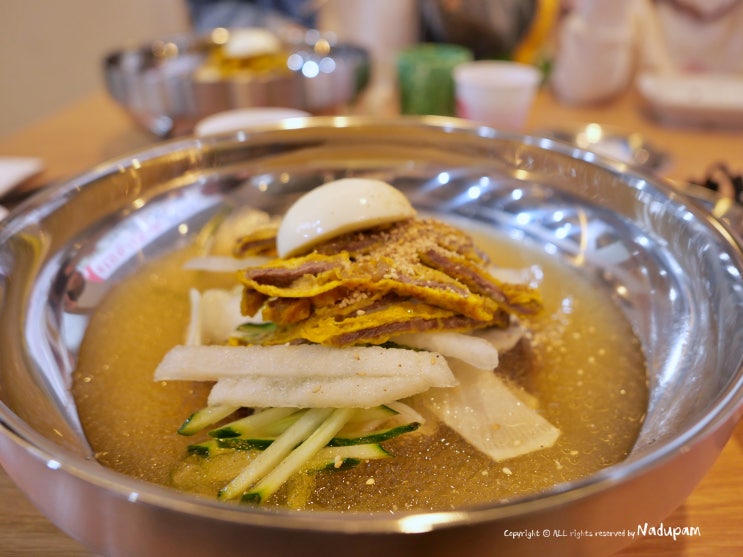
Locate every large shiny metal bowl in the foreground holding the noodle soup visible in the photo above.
<box><xmin>0</xmin><ymin>117</ymin><xmax>743</xmax><ymax>557</ymax></box>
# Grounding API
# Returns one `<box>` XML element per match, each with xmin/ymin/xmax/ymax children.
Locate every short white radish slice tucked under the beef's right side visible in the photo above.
<box><xmin>391</xmin><ymin>332</ymin><xmax>498</xmax><ymax>370</ymax></box>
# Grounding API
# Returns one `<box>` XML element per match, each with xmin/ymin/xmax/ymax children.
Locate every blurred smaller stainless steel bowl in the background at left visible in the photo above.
<box><xmin>103</xmin><ymin>29</ymin><xmax>371</xmax><ymax>137</ymax></box>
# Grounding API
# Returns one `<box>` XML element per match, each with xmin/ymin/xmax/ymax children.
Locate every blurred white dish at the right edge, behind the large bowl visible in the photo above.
<box><xmin>636</xmin><ymin>73</ymin><xmax>743</xmax><ymax>128</ymax></box>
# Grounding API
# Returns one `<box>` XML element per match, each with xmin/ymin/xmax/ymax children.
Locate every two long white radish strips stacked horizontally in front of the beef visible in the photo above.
<box><xmin>155</xmin><ymin>345</ymin><xmax>457</xmax><ymax>408</ymax></box>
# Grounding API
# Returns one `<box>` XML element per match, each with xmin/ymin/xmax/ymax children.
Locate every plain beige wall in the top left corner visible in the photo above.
<box><xmin>0</xmin><ymin>0</ymin><xmax>188</xmax><ymax>138</ymax></box>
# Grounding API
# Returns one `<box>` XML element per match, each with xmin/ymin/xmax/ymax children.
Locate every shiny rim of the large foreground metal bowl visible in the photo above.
<box><xmin>0</xmin><ymin>116</ymin><xmax>743</xmax><ymax>533</ymax></box>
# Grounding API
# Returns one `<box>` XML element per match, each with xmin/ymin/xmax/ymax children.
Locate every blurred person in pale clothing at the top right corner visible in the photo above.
<box><xmin>551</xmin><ymin>0</ymin><xmax>743</xmax><ymax>104</ymax></box>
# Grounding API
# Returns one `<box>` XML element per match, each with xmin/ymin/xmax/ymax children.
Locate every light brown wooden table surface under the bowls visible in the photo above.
<box><xmin>0</xmin><ymin>91</ymin><xmax>743</xmax><ymax>557</ymax></box>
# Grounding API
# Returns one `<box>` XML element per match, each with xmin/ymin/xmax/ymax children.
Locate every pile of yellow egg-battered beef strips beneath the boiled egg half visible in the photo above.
<box><xmin>235</xmin><ymin>218</ymin><xmax>541</xmax><ymax>346</ymax></box>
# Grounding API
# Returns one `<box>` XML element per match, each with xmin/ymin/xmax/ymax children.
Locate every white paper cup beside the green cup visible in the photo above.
<box><xmin>454</xmin><ymin>60</ymin><xmax>542</xmax><ymax>131</ymax></box>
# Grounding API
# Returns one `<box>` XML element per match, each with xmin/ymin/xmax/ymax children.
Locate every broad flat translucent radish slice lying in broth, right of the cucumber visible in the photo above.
<box><xmin>415</xmin><ymin>363</ymin><xmax>560</xmax><ymax>462</ymax></box>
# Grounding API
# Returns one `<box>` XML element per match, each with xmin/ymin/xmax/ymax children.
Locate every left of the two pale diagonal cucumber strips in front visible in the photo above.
<box><xmin>217</xmin><ymin>408</ymin><xmax>333</xmax><ymax>499</ymax></box>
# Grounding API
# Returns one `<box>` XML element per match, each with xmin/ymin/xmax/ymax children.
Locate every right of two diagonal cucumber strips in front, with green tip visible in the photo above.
<box><xmin>242</xmin><ymin>408</ymin><xmax>356</xmax><ymax>503</ymax></box>
